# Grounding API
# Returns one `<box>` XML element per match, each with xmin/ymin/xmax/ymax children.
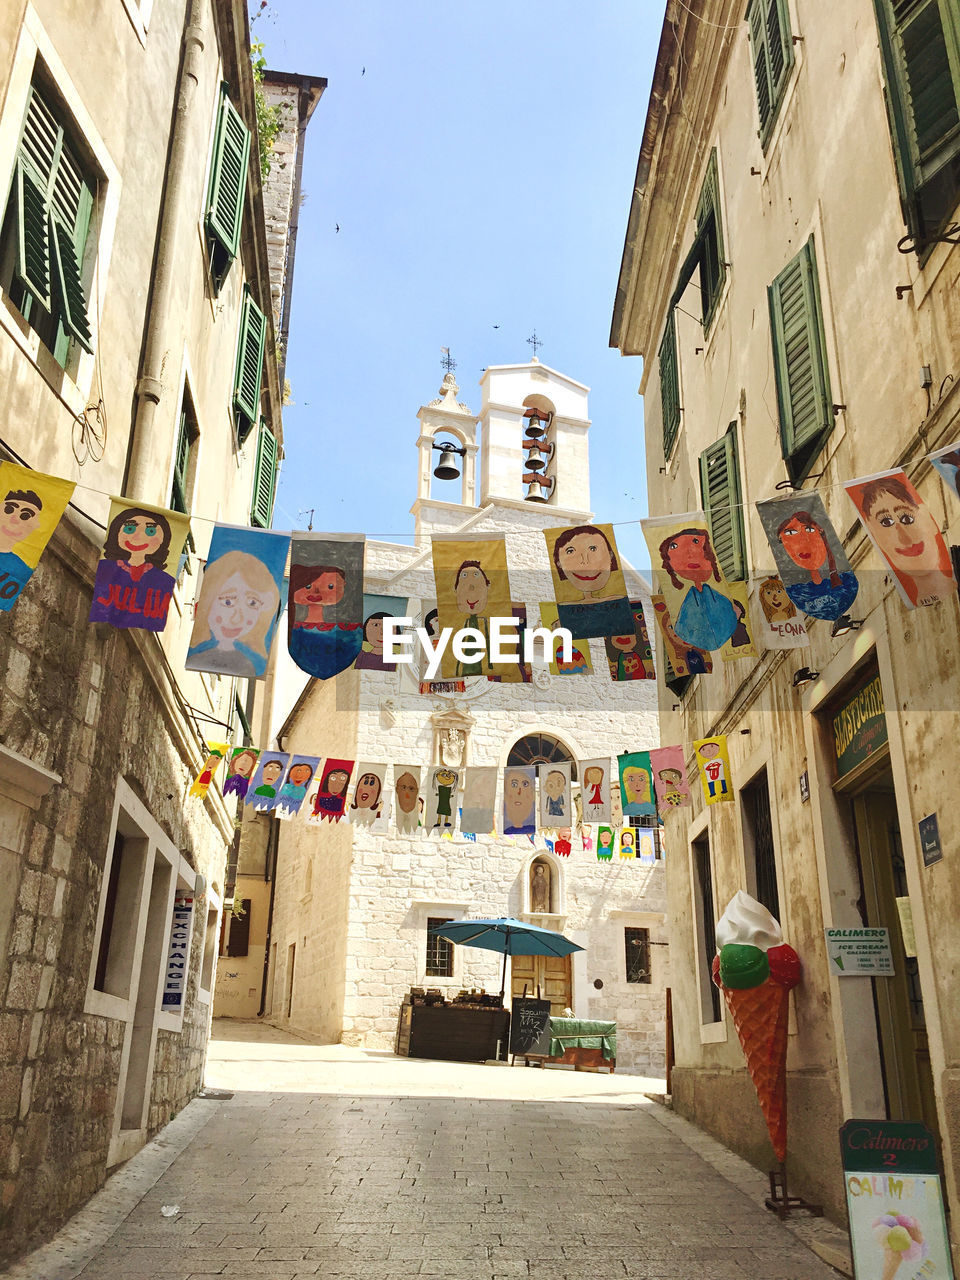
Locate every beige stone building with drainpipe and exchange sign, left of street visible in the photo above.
<box><xmin>0</xmin><ymin>0</ymin><xmax>316</xmax><ymax>1258</ymax></box>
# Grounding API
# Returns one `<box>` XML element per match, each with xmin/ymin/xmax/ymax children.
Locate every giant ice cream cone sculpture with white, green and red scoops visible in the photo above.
<box><xmin>713</xmin><ymin>890</ymin><xmax>803</xmax><ymax>1167</ymax></box>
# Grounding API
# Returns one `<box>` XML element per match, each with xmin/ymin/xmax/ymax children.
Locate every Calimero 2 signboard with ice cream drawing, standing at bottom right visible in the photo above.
<box><xmin>840</xmin><ymin>1120</ymin><xmax>954</xmax><ymax>1280</ymax></box>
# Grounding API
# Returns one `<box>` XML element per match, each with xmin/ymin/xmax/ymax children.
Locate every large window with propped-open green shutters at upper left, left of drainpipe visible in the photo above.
<box><xmin>0</xmin><ymin>84</ymin><xmax>96</xmax><ymax>369</ymax></box>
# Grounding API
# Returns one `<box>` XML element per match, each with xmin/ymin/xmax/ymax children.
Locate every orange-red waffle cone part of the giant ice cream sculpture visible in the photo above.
<box><xmin>722</xmin><ymin>978</ymin><xmax>790</xmax><ymax>1164</ymax></box>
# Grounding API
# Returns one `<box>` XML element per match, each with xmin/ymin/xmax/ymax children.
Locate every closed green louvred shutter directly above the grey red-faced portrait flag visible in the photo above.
<box><xmin>767</xmin><ymin>236</ymin><xmax>833</xmax><ymax>484</ymax></box>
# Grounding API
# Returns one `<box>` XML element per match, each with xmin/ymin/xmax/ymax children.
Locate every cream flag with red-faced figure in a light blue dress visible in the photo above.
<box><xmin>640</xmin><ymin>511</ymin><xmax>740</xmax><ymax>650</ymax></box>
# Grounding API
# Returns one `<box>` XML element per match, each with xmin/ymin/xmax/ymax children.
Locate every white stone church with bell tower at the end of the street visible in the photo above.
<box><xmin>216</xmin><ymin>361</ymin><xmax>667</xmax><ymax>1075</ymax></box>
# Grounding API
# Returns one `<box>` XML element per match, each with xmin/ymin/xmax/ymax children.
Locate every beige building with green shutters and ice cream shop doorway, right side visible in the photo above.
<box><xmin>611</xmin><ymin>0</ymin><xmax>960</xmax><ymax>1216</ymax></box>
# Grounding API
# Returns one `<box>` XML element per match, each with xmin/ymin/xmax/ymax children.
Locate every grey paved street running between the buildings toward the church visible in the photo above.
<box><xmin>14</xmin><ymin>1023</ymin><xmax>836</xmax><ymax>1280</ymax></box>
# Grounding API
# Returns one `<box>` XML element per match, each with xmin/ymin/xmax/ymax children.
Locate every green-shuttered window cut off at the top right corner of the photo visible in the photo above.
<box><xmin>874</xmin><ymin>0</ymin><xmax>960</xmax><ymax>252</ymax></box>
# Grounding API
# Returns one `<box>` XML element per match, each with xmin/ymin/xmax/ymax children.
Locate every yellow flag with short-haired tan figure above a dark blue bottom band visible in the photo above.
<box><xmin>543</xmin><ymin>525</ymin><xmax>634</xmax><ymax>639</ymax></box>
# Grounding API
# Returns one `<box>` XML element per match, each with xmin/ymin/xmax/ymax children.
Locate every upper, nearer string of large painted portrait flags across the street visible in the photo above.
<box><xmin>7</xmin><ymin>442</ymin><xmax>960</xmax><ymax>692</ymax></box>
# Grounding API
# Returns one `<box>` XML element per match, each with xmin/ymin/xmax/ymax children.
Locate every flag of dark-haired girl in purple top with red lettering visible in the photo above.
<box><xmin>90</xmin><ymin>498</ymin><xmax>189</xmax><ymax>631</ymax></box>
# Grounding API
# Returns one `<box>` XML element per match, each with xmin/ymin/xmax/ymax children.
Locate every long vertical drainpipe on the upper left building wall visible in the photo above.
<box><xmin>123</xmin><ymin>0</ymin><xmax>205</xmax><ymax>500</ymax></box>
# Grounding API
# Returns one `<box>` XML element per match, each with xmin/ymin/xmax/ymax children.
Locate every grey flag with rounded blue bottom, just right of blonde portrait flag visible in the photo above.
<box><xmin>287</xmin><ymin>534</ymin><xmax>365</xmax><ymax>680</ymax></box>
